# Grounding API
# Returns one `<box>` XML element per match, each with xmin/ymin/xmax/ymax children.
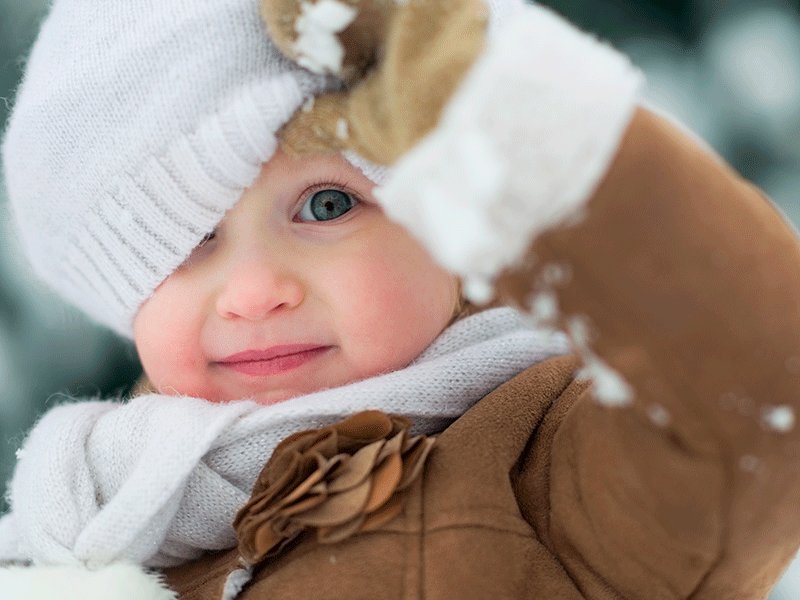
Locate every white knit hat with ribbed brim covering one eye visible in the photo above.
<box><xmin>2</xmin><ymin>0</ymin><xmax>516</xmax><ymax>337</ymax></box>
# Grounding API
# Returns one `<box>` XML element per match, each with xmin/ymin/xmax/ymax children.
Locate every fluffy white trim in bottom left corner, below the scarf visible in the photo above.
<box><xmin>0</xmin><ymin>563</ymin><xmax>178</xmax><ymax>600</ymax></box>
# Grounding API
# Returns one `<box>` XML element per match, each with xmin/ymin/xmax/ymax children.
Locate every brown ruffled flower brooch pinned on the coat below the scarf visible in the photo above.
<box><xmin>233</xmin><ymin>411</ymin><xmax>434</xmax><ymax>566</ymax></box>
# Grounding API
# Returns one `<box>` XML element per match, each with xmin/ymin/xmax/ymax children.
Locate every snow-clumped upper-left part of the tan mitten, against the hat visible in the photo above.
<box><xmin>261</xmin><ymin>0</ymin><xmax>395</xmax><ymax>83</ymax></box>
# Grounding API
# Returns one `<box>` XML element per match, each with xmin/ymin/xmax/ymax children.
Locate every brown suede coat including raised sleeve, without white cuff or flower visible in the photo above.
<box><xmin>165</xmin><ymin>110</ymin><xmax>800</xmax><ymax>600</ymax></box>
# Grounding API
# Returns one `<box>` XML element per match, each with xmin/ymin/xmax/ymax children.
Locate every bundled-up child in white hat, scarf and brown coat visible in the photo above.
<box><xmin>0</xmin><ymin>0</ymin><xmax>800</xmax><ymax>600</ymax></box>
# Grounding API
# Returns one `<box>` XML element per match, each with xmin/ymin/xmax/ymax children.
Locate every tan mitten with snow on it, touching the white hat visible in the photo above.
<box><xmin>262</xmin><ymin>0</ymin><xmax>488</xmax><ymax>165</ymax></box>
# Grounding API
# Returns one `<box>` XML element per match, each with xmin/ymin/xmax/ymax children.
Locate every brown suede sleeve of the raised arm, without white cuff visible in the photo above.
<box><xmin>498</xmin><ymin>109</ymin><xmax>800</xmax><ymax>599</ymax></box>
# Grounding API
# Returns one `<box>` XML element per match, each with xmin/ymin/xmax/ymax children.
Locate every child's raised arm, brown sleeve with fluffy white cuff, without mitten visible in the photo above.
<box><xmin>272</xmin><ymin>0</ymin><xmax>800</xmax><ymax>598</ymax></box>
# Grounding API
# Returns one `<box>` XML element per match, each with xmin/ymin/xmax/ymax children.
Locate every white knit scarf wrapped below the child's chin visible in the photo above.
<box><xmin>0</xmin><ymin>308</ymin><xmax>569</xmax><ymax>567</ymax></box>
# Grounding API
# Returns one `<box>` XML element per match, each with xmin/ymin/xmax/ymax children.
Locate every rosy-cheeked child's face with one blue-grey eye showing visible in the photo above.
<box><xmin>134</xmin><ymin>153</ymin><xmax>457</xmax><ymax>404</ymax></box>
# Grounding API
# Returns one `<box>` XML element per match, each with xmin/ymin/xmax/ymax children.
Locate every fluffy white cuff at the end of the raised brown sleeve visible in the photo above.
<box><xmin>376</xmin><ymin>6</ymin><xmax>643</xmax><ymax>301</ymax></box>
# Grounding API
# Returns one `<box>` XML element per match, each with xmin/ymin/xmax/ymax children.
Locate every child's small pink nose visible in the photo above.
<box><xmin>216</xmin><ymin>261</ymin><xmax>305</xmax><ymax>321</ymax></box>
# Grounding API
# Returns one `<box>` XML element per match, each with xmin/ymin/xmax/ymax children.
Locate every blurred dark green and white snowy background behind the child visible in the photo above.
<box><xmin>0</xmin><ymin>0</ymin><xmax>800</xmax><ymax>600</ymax></box>
